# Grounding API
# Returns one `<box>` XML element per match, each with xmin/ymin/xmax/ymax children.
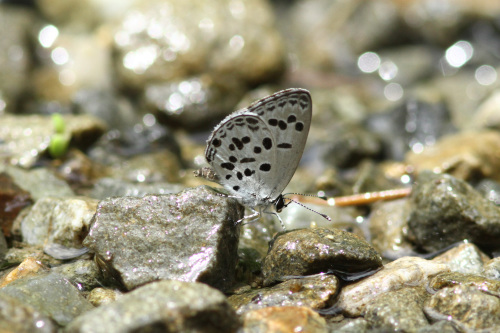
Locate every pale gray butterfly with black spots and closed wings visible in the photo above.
<box><xmin>198</xmin><ymin>88</ymin><xmax>329</xmax><ymax>229</ymax></box>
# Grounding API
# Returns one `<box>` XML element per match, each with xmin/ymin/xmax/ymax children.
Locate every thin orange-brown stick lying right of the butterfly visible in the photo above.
<box><xmin>292</xmin><ymin>188</ymin><xmax>411</xmax><ymax>206</ymax></box>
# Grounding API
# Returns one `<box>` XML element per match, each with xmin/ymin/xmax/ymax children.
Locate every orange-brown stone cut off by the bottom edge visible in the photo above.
<box><xmin>243</xmin><ymin>306</ymin><xmax>328</xmax><ymax>333</ymax></box>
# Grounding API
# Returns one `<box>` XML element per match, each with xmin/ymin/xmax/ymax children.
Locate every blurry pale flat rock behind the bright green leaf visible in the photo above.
<box><xmin>0</xmin><ymin>115</ymin><xmax>105</xmax><ymax>167</ymax></box>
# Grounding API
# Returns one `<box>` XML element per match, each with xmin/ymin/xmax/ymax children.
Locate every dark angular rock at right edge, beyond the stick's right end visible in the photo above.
<box><xmin>408</xmin><ymin>171</ymin><xmax>500</xmax><ymax>252</ymax></box>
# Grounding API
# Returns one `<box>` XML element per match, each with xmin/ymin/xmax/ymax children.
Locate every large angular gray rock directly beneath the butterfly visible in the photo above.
<box><xmin>84</xmin><ymin>187</ymin><xmax>243</xmax><ymax>289</ymax></box>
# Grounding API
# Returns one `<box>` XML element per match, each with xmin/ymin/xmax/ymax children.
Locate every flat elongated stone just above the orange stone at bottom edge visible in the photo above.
<box><xmin>228</xmin><ymin>275</ymin><xmax>339</xmax><ymax>314</ymax></box>
